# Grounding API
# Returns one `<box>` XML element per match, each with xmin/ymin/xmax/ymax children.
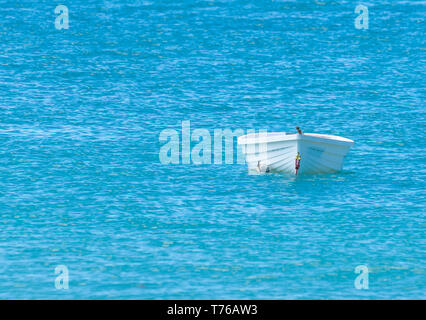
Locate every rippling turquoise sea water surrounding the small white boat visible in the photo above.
<box><xmin>0</xmin><ymin>0</ymin><xmax>426</xmax><ymax>299</ymax></box>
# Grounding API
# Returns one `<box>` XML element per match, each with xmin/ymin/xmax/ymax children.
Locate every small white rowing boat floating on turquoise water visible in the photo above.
<box><xmin>238</xmin><ymin>128</ymin><xmax>354</xmax><ymax>174</ymax></box>
